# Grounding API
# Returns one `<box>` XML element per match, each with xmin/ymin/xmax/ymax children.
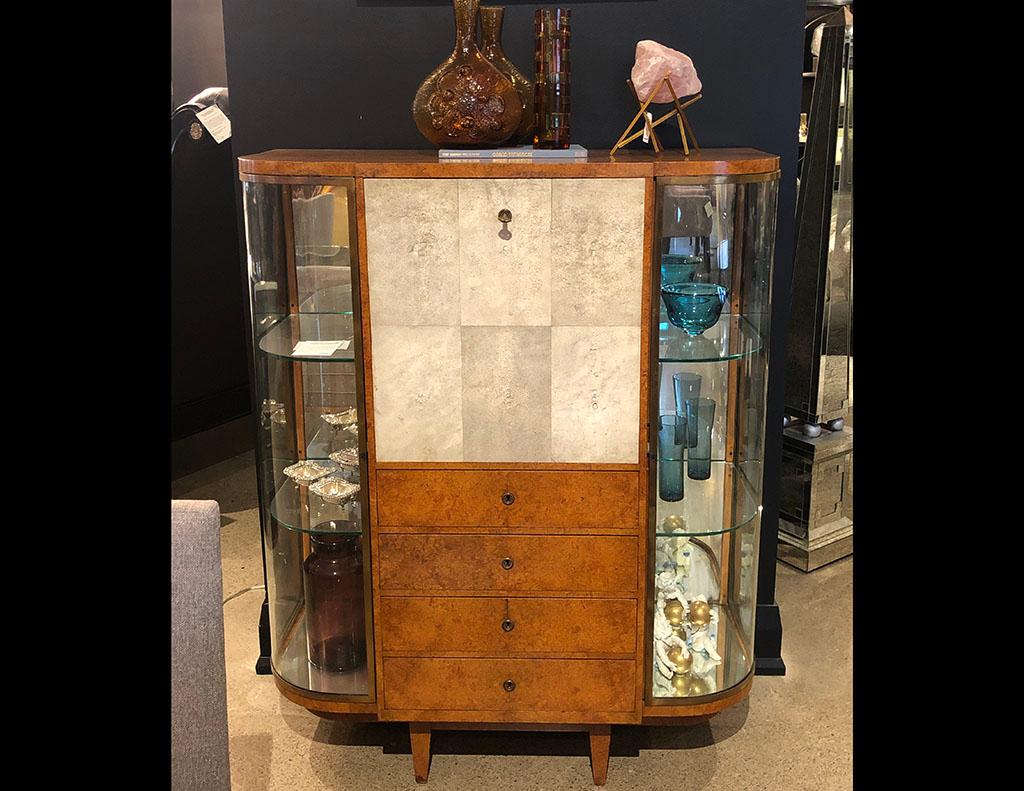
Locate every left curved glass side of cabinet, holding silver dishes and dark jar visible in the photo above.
<box><xmin>243</xmin><ymin>178</ymin><xmax>374</xmax><ymax>700</ymax></box>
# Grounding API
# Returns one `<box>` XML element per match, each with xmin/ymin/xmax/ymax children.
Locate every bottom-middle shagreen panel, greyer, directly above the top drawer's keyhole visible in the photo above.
<box><xmin>462</xmin><ymin>327</ymin><xmax>551</xmax><ymax>461</ymax></box>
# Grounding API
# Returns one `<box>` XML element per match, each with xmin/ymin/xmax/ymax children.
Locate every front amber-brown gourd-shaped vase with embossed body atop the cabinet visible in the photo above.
<box><xmin>413</xmin><ymin>0</ymin><xmax>522</xmax><ymax>148</ymax></box>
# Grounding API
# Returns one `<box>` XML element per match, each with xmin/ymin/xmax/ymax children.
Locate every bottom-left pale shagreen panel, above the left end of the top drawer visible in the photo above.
<box><xmin>373</xmin><ymin>326</ymin><xmax>462</xmax><ymax>461</ymax></box>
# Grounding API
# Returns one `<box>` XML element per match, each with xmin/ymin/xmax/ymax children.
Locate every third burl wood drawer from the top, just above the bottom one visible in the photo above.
<box><xmin>377</xmin><ymin>596</ymin><xmax>637</xmax><ymax>657</ymax></box>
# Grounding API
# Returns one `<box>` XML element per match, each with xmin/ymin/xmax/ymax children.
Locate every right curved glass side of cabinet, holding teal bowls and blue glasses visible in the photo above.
<box><xmin>646</xmin><ymin>173</ymin><xmax>778</xmax><ymax>705</ymax></box>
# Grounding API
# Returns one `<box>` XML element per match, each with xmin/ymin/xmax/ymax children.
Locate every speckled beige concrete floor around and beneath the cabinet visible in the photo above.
<box><xmin>172</xmin><ymin>454</ymin><xmax>853</xmax><ymax>791</ymax></box>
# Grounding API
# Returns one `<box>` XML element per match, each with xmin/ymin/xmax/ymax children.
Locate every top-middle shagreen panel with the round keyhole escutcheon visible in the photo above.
<box><xmin>459</xmin><ymin>178</ymin><xmax>551</xmax><ymax>327</ymax></box>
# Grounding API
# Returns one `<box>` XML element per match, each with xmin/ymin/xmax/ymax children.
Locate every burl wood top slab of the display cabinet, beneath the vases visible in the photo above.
<box><xmin>239</xmin><ymin>149</ymin><xmax>779</xmax><ymax>181</ymax></box>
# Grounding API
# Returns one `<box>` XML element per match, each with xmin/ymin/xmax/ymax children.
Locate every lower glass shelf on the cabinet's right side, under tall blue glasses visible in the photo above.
<box><xmin>654</xmin><ymin>461</ymin><xmax>761</xmax><ymax>538</ymax></box>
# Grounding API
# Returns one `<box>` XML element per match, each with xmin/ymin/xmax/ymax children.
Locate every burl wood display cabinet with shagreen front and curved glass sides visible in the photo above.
<box><xmin>240</xmin><ymin>149</ymin><xmax>778</xmax><ymax>785</ymax></box>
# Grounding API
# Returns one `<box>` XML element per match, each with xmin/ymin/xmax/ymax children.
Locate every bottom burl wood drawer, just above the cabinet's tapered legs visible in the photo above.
<box><xmin>383</xmin><ymin>657</ymin><xmax>636</xmax><ymax>721</ymax></box>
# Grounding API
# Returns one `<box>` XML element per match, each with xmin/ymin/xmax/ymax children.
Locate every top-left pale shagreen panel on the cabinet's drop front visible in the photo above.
<box><xmin>364</xmin><ymin>178</ymin><xmax>460</xmax><ymax>325</ymax></box>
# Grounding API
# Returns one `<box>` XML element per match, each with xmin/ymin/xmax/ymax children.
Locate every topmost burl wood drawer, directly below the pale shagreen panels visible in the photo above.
<box><xmin>377</xmin><ymin>469</ymin><xmax>640</xmax><ymax>529</ymax></box>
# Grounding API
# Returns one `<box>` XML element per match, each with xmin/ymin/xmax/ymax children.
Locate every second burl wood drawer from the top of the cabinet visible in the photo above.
<box><xmin>379</xmin><ymin>533</ymin><xmax>638</xmax><ymax>596</ymax></box>
